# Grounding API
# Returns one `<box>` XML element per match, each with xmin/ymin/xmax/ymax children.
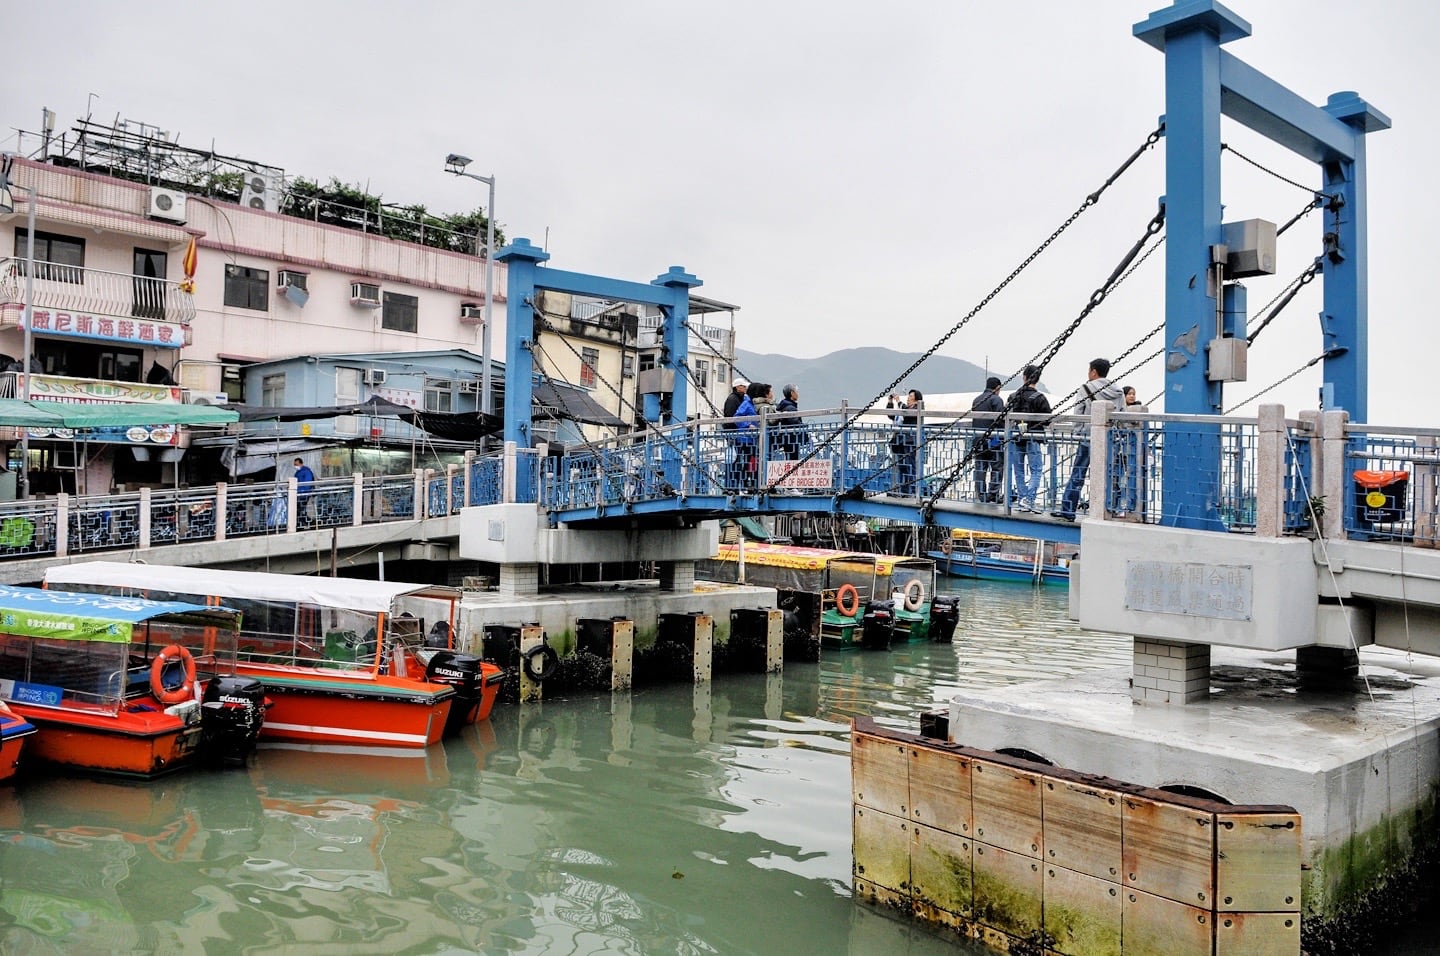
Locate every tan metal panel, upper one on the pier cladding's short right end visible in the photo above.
<box><xmin>1215</xmin><ymin>812</ymin><xmax>1300</xmax><ymax>909</ymax></box>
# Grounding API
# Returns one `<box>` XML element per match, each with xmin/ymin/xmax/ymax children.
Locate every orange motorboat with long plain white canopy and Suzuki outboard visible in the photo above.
<box><xmin>45</xmin><ymin>562</ymin><xmax>503</xmax><ymax>747</ymax></box>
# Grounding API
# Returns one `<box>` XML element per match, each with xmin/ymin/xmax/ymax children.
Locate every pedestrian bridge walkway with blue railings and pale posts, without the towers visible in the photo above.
<box><xmin>0</xmin><ymin>406</ymin><xmax>1440</xmax><ymax>579</ymax></box>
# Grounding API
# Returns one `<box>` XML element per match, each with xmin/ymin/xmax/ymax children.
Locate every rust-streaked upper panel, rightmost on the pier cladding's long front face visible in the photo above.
<box><xmin>1120</xmin><ymin>795</ymin><xmax>1215</xmax><ymax>910</ymax></box>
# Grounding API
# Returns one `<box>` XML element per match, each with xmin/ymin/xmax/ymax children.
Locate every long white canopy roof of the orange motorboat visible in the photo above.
<box><xmin>45</xmin><ymin>562</ymin><xmax>459</xmax><ymax>613</ymax></box>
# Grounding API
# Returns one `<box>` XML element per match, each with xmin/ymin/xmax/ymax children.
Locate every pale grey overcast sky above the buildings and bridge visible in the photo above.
<box><xmin>0</xmin><ymin>0</ymin><xmax>1440</xmax><ymax>425</ymax></box>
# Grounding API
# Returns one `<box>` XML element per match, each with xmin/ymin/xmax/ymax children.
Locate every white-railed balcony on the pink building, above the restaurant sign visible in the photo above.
<box><xmin>0</xmin><ymin>258</ymin><xmax>194</xmax><ymax>328</ymax></box>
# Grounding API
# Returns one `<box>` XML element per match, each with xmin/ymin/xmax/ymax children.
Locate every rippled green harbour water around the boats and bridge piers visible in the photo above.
<box><xmin>0</xmin><ymin>587</ymin><xmax>1129</xmax><ymax>956</ymax></box>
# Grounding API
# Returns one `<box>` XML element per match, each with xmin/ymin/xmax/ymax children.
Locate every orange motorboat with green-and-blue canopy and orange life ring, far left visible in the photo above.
<box><xmin>0</xmin><ymin>586</ymin><xmax>265</xmax><ymax>777</ymax></box>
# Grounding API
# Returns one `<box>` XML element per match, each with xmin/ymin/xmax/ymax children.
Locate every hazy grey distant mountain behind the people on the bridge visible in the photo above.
<box><xmin>734</xmin><ymin>347</ymin><xmax>1002</xmax><ymax>409</ymax></box>
